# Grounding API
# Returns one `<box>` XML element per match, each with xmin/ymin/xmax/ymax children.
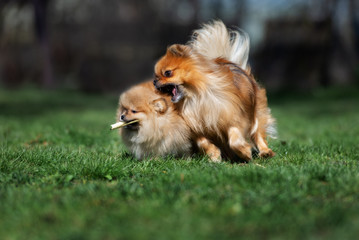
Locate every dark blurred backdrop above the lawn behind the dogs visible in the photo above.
<box><xmin>0</xmin><ymin>0</ymin><xmax>359</xmax><ymax>93</ymax></box>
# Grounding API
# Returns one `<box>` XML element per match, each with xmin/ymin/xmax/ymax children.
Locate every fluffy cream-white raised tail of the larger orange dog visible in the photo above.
<box><xmin>189</xmin><ymin>21</ymin><xmax>249</xmax><ymax>70</ymax></box>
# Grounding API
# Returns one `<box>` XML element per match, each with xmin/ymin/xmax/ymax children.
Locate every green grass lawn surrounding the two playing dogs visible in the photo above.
<box><xmin>0</xmin><ymin>89</ymin><xmax>359</xmax><ymax>240</ymax></box>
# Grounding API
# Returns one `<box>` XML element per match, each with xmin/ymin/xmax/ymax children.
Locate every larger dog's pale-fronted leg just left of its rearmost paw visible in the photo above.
<box><xmin>228</xmin><ymin>127</ymin><xmax>252</xmax><ymax>162</ymax></box>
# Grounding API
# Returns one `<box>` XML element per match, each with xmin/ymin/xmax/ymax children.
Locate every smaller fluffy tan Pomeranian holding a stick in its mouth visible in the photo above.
<box><xmin>117</xmin><ymin>81</ymin><xmax>220</xmax><ymax>159</ymax></box>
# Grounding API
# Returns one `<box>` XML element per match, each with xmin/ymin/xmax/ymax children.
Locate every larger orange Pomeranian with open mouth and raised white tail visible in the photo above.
<box><xmin>153</xmin><ymin>21</ymin><xmax>275</xmax><ymax>162</ymax></box>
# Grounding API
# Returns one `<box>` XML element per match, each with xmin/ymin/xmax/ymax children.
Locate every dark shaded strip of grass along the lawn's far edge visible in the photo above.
<box><xmin>0</xmin><ymin>87</ymin><xmax>359</xmax><ymax>118</ymax></box>
